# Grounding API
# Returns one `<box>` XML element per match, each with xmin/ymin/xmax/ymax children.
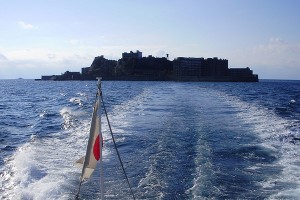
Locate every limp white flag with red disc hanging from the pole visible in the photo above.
<box><xmin>76</xmin><ymin>101</ymin><xmax>102</xmax><ymax>181</ymax></box>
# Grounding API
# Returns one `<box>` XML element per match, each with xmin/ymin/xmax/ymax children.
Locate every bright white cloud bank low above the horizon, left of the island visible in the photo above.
<box><xmin>0</xmin><ymin>48</ymin><xmax>94</xmax><ymax>79</ymax></box>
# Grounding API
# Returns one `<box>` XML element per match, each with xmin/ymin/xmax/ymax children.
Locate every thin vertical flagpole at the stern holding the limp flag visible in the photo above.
<box><xmin>97</xmin><ymin>77</ymin><xmax>104</xmax><ymax>200</ymax></box>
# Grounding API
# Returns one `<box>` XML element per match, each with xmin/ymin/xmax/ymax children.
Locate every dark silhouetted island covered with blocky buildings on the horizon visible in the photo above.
<box><xmin>36</xmin><ymin>51</ymin><xmax>258</xmax><ymax>82</ymax></box>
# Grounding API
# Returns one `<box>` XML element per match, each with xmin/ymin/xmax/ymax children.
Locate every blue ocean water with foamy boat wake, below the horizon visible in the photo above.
<box><xmin>0</xmin><ymin>80</ymin><xmax>300</xmax><ymax>200</ymax></box>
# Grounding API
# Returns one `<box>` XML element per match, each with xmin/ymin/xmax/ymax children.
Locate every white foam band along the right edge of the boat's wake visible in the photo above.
<box><xmin>220</xmin><ymin>92</ymin><xmax>300</xmax><ymax>199</ymax></box>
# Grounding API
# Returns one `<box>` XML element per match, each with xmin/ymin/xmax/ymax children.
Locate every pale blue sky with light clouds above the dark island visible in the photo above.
<box><xmin>0</xmin><ymin>0</ymin><xmax>300</xmax><ymax>80</ymax></box>
